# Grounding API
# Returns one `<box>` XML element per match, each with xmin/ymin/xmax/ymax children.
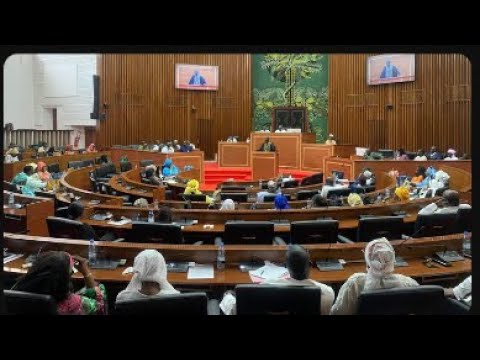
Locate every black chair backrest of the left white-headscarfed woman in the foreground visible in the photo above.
<box><xmin>114</xmin><ymin>292</ymin><xmax>207</xmax><ymax>316</ymax></box>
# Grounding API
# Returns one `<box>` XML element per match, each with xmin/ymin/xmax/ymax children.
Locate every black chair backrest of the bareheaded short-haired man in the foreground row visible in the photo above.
<box><xmin>235</xmin><ymin>284</ymin><xmax>322</xmax><ymax>315</ymax></box>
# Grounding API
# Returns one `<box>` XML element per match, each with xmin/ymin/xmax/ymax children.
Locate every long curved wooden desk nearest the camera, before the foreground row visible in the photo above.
<box><xmin>4</xmin><ymin>233</ymin><xmax>472</xmax><ymax>286</ymax></box>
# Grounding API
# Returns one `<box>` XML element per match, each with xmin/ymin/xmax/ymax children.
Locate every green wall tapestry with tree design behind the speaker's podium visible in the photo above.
<box><xmin>252</xmin><ymin>54</ymin><xmax>328</xmax><ymax>142</ymax></box>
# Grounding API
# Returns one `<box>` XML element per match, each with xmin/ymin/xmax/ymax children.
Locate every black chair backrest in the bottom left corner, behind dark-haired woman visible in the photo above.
<box><xmin>3</xmin><ymin>290</ymin><xmax>57</xmax><ymax>315</ymax></box>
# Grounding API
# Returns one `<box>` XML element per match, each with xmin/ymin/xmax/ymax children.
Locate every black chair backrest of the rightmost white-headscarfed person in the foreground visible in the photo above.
<box><xmin>357</xmin><ymin>285</ymin><xmax>447</xmax><ymax>315</ymax></box>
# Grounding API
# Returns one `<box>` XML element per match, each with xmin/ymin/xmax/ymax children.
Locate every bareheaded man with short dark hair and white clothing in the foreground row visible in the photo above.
<box><xmin>220</xmin><ymin>245</ymin><xmax>335</xmax><ymax>315</ymax></box>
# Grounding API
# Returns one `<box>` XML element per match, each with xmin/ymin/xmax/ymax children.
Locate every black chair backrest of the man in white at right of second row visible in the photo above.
<box><xmin>414</xmin><ymin>213</ymin><xmax>458</xmax><ymax>237</ymax></box>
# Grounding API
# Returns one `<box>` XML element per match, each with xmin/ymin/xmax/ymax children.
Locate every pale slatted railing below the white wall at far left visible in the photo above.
<box><xmin>3</xmin><ymin>130</ymin><xmax>73</xmax><ymax>150</ymax></box>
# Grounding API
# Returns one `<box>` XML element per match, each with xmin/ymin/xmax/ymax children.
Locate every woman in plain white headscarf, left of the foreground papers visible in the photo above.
<box><xmin>117</xmin><ymin>250</ymin><xmax>179</xmax><ymax>301</ymax></box>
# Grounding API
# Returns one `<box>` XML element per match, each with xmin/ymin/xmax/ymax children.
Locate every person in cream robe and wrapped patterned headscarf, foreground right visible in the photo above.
<box><xmin>330</xmin><ymin>238</ymin><xmax>418</xmax><ymax>315</ymax></box>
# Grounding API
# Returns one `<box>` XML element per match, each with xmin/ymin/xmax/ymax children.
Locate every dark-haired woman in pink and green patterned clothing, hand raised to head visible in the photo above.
<box><xmin>12</xmin><ymin>251</ymin><xmax>107</xmax><ymax>315</ymax></box>
